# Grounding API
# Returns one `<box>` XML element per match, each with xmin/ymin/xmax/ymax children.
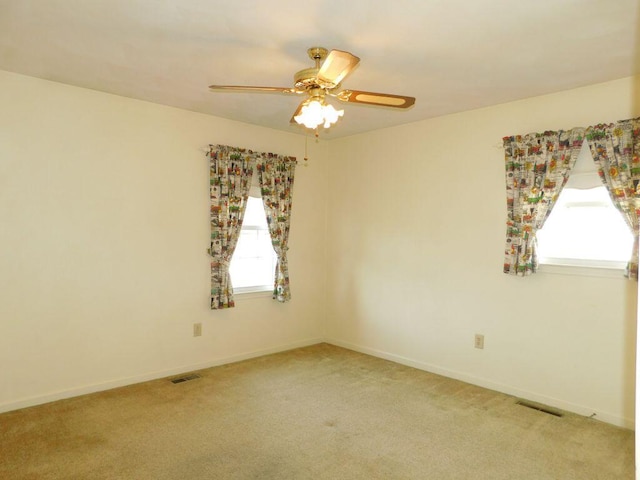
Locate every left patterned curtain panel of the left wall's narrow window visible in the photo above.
<box><xmin>209</xmin><ymin>145</ymin><xmax>255</xmax><ymax>310</ymax></box>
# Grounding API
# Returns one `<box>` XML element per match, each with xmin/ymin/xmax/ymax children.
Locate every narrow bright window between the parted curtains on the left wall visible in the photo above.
<box><xmin>229</xmin><ymin>180</ymin><xmax>277</xmax><ymax>294</ymax></box>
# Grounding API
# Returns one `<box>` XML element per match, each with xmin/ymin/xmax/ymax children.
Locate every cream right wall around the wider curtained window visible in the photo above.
<box><xmin>326</xmin><ymin>79</ymin><xmax>639</xmax><ymax>426</ymax></box>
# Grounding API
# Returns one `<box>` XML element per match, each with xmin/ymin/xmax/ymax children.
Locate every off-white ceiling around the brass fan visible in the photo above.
<box><xmin>0</xmin><ymin>0</ymin><xmax>640</xmax><ymax>138</ymax></box>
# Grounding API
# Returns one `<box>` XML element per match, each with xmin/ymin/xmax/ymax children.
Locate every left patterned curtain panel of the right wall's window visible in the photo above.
<box><xmin>503</xmin><ymin>128</ymin><xmax>584</xmax><ymax>276</ymax></box>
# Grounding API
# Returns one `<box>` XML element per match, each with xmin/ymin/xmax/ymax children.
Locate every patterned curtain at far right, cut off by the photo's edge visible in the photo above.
<box><xmin>586</xmin><ymin>118</ymin><xmax>640</xmax><ymax>280</ymax></box>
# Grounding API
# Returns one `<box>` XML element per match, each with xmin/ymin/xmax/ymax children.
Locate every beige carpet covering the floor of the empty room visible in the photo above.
<box><xmin>0</xmin><ymin>344</ymin><xmax>634</xmax><ymax>480</ymax></box>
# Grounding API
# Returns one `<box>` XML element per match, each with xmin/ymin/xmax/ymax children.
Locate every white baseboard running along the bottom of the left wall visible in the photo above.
<box><xmin>0</xmin><ymin>338</ymin><xmax>324</xmax><ymax>413</ymax></box>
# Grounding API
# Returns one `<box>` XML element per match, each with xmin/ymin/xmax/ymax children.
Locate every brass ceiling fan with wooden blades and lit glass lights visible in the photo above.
<box><xmin>209</xmin><ymin>47</ymin><xmax>416</xmax><ymax>136</ymax></box>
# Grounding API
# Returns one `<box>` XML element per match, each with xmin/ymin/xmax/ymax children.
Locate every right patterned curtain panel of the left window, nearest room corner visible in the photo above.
<box><xmin>256</xmin><ymin>153</ymin><xmax>296</xmax><ymax>302</ymax></box>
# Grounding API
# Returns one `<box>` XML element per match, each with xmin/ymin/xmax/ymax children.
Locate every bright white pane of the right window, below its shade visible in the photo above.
<box><xmin>538</xmin><ymin>186</ymin><xmax>633</xmax><ymax>263</ymax></box>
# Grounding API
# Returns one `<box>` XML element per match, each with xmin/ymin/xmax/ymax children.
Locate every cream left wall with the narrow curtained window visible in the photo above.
<box><xmin>0</xmin><ymin>72</ymin><xmax>327</xmax><ymax>411</ymax></box>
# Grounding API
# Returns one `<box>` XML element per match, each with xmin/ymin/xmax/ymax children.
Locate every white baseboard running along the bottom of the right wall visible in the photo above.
<box><xmin>325</xmin><ymin>339</ymin><xmax>635</xmax><ymax>430</ymax></box>
